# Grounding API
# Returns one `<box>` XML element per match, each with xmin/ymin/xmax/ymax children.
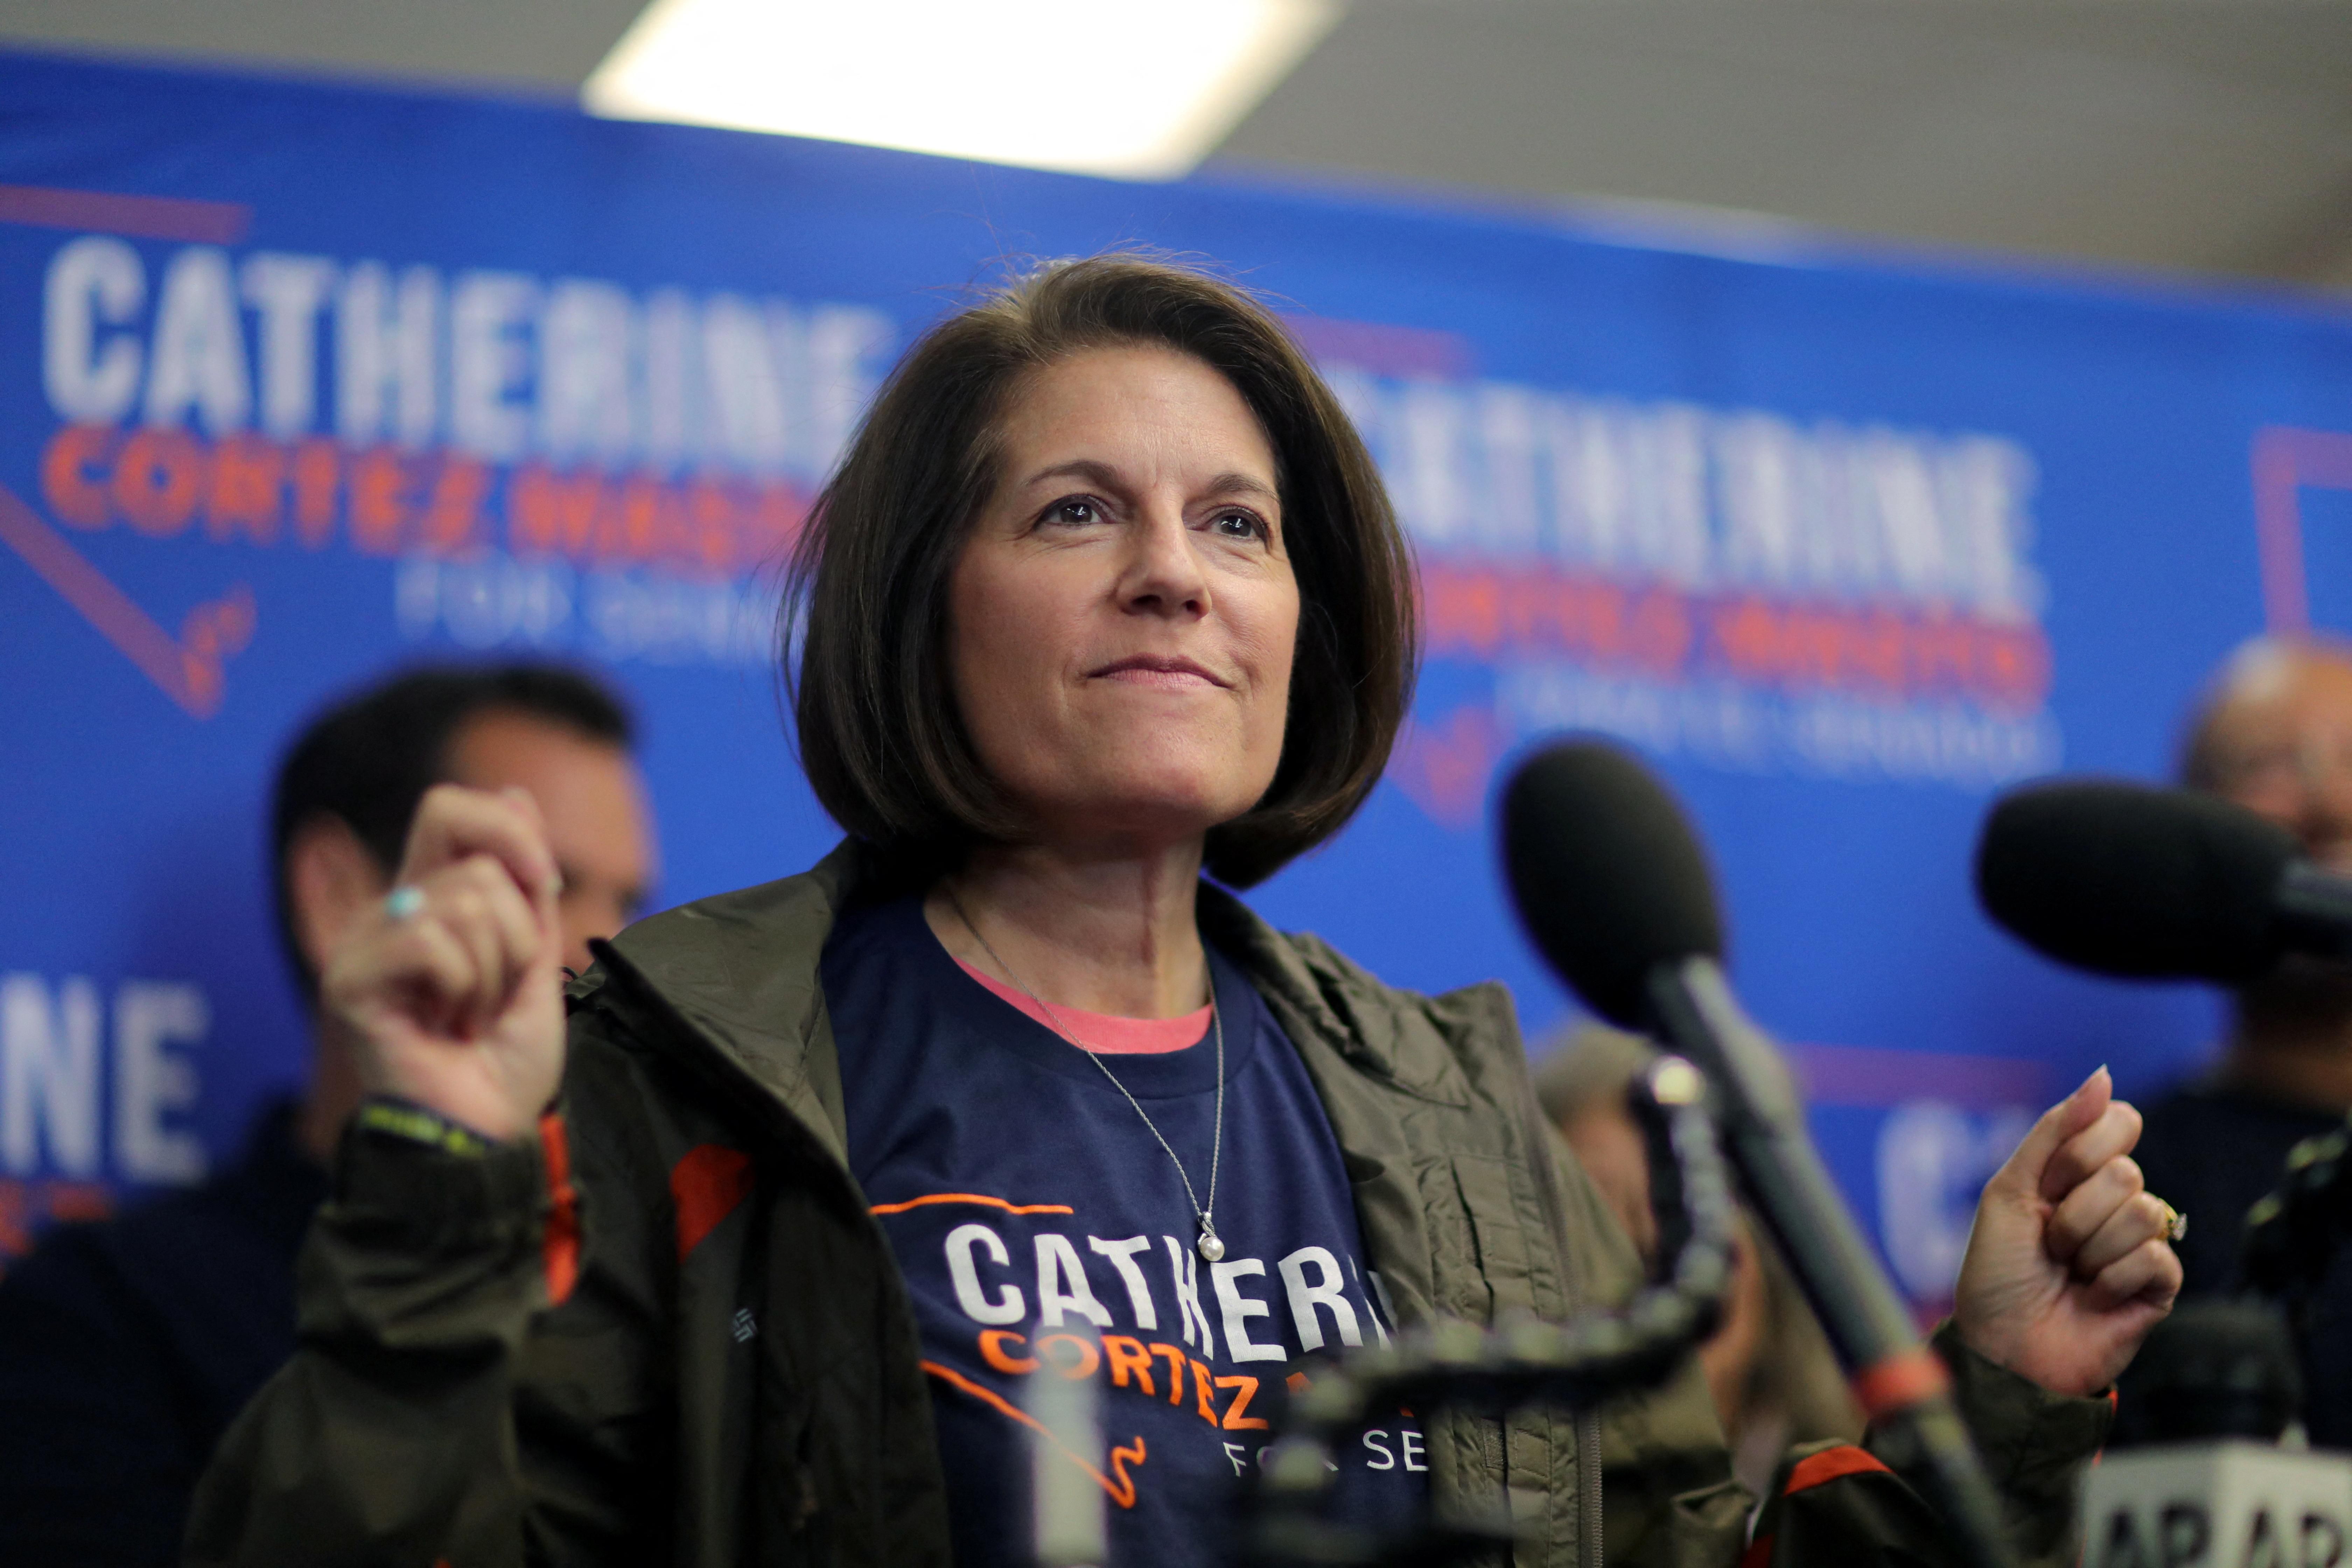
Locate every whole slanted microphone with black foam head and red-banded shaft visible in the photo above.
<box><xmin>1503</xmin><ymin>741</ymin><xmax>2011</xmax><ymax>1563</ymax></box>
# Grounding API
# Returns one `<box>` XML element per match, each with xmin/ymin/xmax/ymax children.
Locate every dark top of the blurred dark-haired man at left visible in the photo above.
<box><xmin>0</xmin><ymin>1102</ymin><xmax>327</xmax><ymax>1568</ymax></box>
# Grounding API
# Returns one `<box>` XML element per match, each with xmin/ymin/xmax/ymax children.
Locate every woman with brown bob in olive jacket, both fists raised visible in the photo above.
<box><xmin>188</xmin><ymin>256</ymin><xmax>2178</xmax><ymax>1568</ymax></box>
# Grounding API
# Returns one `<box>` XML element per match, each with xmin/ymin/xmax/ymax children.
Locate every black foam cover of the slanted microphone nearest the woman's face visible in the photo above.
<box><xmin>1503</xmin><ymin>741</ymin><xmax>1724</xmax><ymax>1027</ymax></box>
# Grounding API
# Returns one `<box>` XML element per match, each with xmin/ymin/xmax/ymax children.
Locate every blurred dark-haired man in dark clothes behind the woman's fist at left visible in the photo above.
<box><xmin>0</xmin><ymin>665</ymin><xmax>654</xmax><ymax>1568</ymax></box>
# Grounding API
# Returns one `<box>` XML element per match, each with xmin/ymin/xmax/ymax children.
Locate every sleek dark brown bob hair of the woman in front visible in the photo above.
<box><xmin>783</xmin><ymin>254</ymin><xmax>1418</xmax><ymax>886</ymax></box>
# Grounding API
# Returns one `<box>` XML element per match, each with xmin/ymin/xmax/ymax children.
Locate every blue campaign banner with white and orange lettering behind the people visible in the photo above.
<box><xmin>0</xmin><ymin>56</ymin><xmax>2352</xmax><ymax>1302</ymax></box>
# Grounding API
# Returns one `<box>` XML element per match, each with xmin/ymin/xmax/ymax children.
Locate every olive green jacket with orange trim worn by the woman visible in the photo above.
<box><xmin>188</xmin><ymin>846</ymin><xmax>2107</xmax><ymax>1568</ymax></box>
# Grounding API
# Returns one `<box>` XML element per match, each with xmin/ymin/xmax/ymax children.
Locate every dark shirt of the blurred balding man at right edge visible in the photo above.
<box><xmin>2133</xmin><ymin>1084</ymin><xmax>2352</xmax><ymax>1448</ymax></box>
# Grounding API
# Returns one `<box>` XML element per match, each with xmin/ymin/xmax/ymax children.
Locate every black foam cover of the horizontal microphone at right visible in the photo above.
<box><xmin>1976</xmin><ymin>780</ymin><xmax>2298</xmax><ymax>985</ymax></box>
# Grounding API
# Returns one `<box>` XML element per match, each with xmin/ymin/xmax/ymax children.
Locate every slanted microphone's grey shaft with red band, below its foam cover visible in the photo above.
<box><xmin>1649</xmin><ymin>957</ymin><xmax>2013</xmax><ymax>1568</ymax></box>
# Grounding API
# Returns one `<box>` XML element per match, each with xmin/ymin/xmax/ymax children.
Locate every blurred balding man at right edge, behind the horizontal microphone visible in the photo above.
<box><xmin>2138</xmin><ymin>637</ymin><xmax>2352</xmax><ymax>1448</ymax></box>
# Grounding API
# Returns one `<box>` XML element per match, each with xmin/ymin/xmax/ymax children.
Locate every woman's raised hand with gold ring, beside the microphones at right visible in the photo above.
<box><xmin>1952</xmin><ymin>1067</ymin><xmax>2180</xmax><ymax>1394</ymax></box>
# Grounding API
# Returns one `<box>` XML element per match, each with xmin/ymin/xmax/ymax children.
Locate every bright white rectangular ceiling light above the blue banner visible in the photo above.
<box><xmin>581</xmin><ymin>0</ymin><xmax>1340</xmax><ymax>178</ymax></box>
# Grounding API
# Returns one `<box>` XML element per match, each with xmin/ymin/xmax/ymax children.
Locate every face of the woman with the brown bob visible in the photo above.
<box><xmin>948</xmin><ymin>348</ymin><xmax>1298</xmax><ymax>842</ymax></box>
